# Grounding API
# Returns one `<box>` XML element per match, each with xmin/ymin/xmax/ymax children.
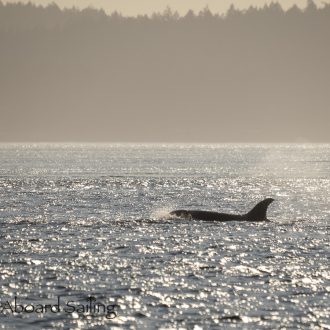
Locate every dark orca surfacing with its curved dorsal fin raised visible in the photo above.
<box><xmin>170</xmin><ymin>198</ymin><xmax>274</xmax><ymax>222</ymax></box>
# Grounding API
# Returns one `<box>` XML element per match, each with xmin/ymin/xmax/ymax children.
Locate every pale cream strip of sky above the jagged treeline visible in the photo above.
<box><xmin>3</xmin><ymin>0</ymin><xmax>329</xmax><ymax>16</ymax></box>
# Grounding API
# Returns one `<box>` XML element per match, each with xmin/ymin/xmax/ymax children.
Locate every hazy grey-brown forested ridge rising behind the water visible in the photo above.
<box><xmin>0</xmin><ymin>1</ymin><xmax>330</xmax><ymax>142</ymax></box>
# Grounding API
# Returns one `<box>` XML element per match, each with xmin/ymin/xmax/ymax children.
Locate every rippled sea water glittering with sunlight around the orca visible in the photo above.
<box><xmin>0</xmin><ymin>144</ymin><xmax>330</xmax><ymax>330</ymax></box>
